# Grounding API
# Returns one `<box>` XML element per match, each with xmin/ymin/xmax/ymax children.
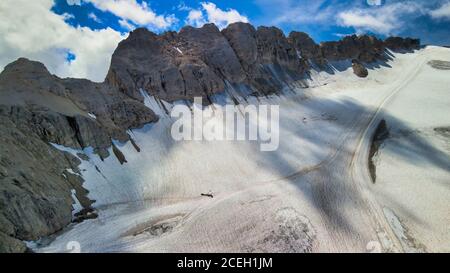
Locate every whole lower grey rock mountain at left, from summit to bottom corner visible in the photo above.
<box><xmin>0</xmin><ymin>59</ymin><xmax>157</xmax><ymax>252</ymax></box>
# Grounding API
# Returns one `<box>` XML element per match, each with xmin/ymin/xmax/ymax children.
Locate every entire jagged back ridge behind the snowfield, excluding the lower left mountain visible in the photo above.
<box><xmin>105</xmin><ymin>23</ymin><xmax>422</xmax><ymax>101</ymax></box>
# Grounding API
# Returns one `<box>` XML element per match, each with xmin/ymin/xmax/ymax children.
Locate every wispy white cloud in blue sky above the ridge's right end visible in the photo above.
<box><xmin>338</xmin><ymin>1</ymin><xmax>424</xmax><ymax>35</ymax></box>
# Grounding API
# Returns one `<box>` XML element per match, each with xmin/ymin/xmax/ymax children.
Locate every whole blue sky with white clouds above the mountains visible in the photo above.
<box><xmin>0</xmin><ymin>0</ymin><xmax>450</xmax><ymax>81</ymax></box>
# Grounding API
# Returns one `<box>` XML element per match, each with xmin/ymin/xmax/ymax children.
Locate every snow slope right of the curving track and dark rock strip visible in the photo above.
<box><xmin>374</xmin><ymin>47</ymin><xmax>450</xmax><ymax>252</ymax></box>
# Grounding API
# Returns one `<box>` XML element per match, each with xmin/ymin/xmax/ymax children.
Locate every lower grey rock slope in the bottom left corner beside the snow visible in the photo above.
<box><xmin>0</xmin><ymin>106</ymin><xmax>82</xmax><ymax>249</ymax></box>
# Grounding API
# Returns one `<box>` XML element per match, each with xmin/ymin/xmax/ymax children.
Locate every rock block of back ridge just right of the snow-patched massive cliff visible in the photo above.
<box><xmin>222</xmin><ymin>23</ymin><xmax>306</xmax><ymax>94</ymax></box>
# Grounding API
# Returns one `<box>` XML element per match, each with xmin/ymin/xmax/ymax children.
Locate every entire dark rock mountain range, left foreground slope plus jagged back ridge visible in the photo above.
<box><xmin>0</xmin><ymin>23</ymin><xmax>420</xmax><ymax>252</ymax></box>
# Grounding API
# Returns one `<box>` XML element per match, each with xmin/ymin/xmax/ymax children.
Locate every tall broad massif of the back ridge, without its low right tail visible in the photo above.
<box><xmin>106</xmin><ymin>23</ymin><xmax>310</xmax><ymax>101</ymax></box>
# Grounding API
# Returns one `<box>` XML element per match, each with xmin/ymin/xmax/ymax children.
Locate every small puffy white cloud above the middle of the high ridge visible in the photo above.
<box><xmin>183</xmin><ymin>2</ymin><xmax>249</xmax><ymax>29</ymax></box>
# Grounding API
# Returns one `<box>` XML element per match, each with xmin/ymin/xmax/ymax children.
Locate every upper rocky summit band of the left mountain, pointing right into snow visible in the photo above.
<box><xmin>0</xmin><ymin>59</ymin><xmax>157</xmax><ymax>153</ymax></box>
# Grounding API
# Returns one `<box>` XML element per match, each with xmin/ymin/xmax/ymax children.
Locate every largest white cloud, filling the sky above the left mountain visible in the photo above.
<box><xmin>0</xmin><ymin>0</ymin><xmax>125</xmax><ymax>81</ymax></box>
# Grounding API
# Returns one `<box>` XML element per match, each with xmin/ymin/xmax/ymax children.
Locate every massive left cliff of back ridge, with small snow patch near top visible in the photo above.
<box><xmin>106</xmin><ymin>24</ymin><xmax>243</xmax><ymax>101</ymax></box>
